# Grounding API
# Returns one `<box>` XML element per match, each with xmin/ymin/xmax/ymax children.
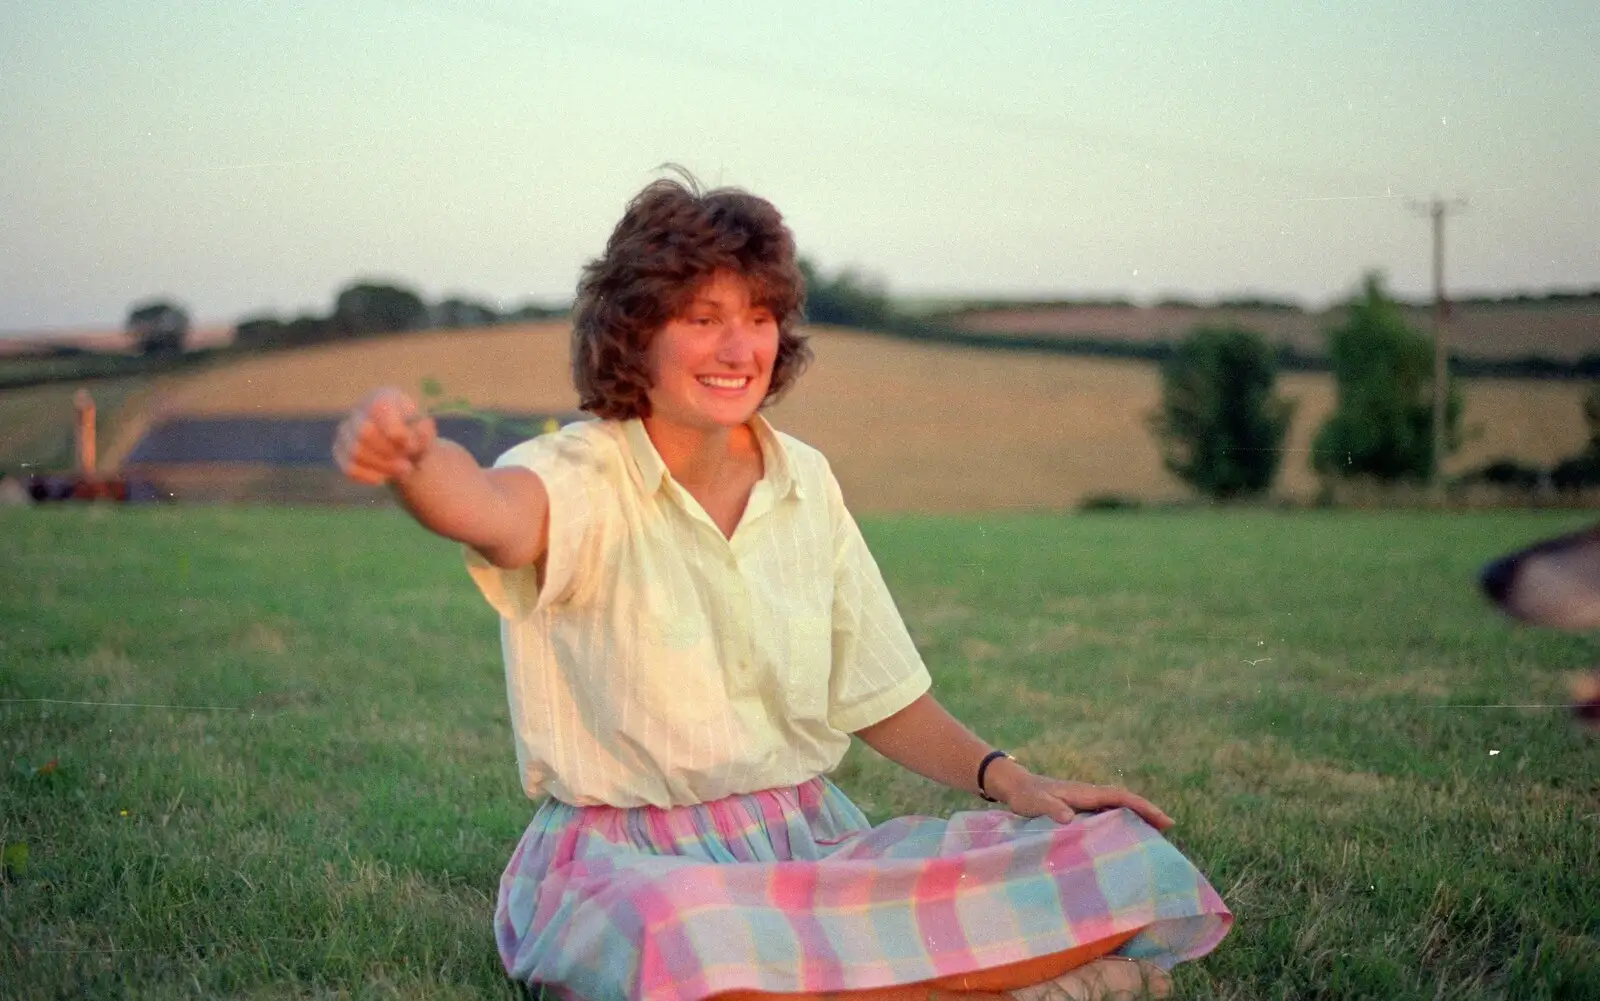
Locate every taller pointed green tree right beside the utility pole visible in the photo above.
<box><xmin>1312</xmin><ymin>272</ymin><xmax>1461</xmax><ymax>483</ymax></box>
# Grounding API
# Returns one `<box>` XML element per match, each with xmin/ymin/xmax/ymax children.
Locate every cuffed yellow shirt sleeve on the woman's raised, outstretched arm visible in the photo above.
<box><xmin>462</xmin><ymin>424</ymin><xmax>606</xmax><ymax>620</ymax></box>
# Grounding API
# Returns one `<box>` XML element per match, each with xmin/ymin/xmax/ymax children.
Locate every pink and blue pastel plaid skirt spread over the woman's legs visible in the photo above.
<box><xmin>494</xmin><ymin>777</ymin><xmax>1232</xmax><ymax>1001</ymax></box>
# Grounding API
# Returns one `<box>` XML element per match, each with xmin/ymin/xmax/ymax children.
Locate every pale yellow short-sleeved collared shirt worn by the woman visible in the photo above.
<box><xmin>466</xmin><ymin>416</ymin><xmax>930</xmax><ymax>808</ymax></box>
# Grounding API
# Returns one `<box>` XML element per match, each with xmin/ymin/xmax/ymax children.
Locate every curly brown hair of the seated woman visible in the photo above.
<box><xmin>573</xmin><ymin>168</ymin><xmax>811</xmax><ymax>419</ymax></box>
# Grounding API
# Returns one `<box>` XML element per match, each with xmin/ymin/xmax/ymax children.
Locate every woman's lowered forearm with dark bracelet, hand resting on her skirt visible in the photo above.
<box><xmin>856</xmin><ymin>694</ymin><xmax>1173</xmax><ymax>830</ymax></box>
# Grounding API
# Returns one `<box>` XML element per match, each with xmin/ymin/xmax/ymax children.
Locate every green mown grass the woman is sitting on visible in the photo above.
<box><xmin>0</xmin><ymin>508</ymin><xmax>1600</xmax><ymax>999</ymax></box>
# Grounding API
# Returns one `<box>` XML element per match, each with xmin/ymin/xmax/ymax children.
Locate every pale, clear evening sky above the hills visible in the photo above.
<box><xmin>0</xmin><ymin>0</ymin><xmax>1600</xmax><ymax>333</ymax></box>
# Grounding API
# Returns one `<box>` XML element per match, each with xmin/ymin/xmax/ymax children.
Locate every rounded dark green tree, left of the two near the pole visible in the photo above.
<box><xmin>1150</xmin><ymin>326</ymin><xmax>1294</xmax><ymax>501</ymax></box>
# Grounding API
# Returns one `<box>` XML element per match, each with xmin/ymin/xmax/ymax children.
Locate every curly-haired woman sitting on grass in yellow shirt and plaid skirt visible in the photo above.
<box><xmin>334</xmin><ymin>179</ymin><xmax>1232</xmax><ymax>1001</ymax></box>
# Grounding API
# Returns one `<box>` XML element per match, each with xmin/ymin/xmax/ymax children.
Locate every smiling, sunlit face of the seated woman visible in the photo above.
<box><xmin>648</xmin><ymin>272</ymin><xmax>778</xmax><ymax>432</ymax></box>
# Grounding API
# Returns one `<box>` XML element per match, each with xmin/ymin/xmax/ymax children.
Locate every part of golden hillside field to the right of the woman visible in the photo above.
<box><xmin>773</xmin><ymin>333</ymin><xmax>1586</xmax><ymax>512</ymax></box>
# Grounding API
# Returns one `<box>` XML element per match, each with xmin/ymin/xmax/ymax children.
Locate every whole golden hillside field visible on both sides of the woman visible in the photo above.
<box><xmin>81</xmin><ymin>321</ymin><xmax>1587</xmax><ymax>512</ymax></box>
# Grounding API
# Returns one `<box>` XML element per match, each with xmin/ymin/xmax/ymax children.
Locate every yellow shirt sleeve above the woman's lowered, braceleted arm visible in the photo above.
<box><xmin>824</xmin><ymin>457</ymin><xmax>933</xmax><ymax>734</ymax></box>
